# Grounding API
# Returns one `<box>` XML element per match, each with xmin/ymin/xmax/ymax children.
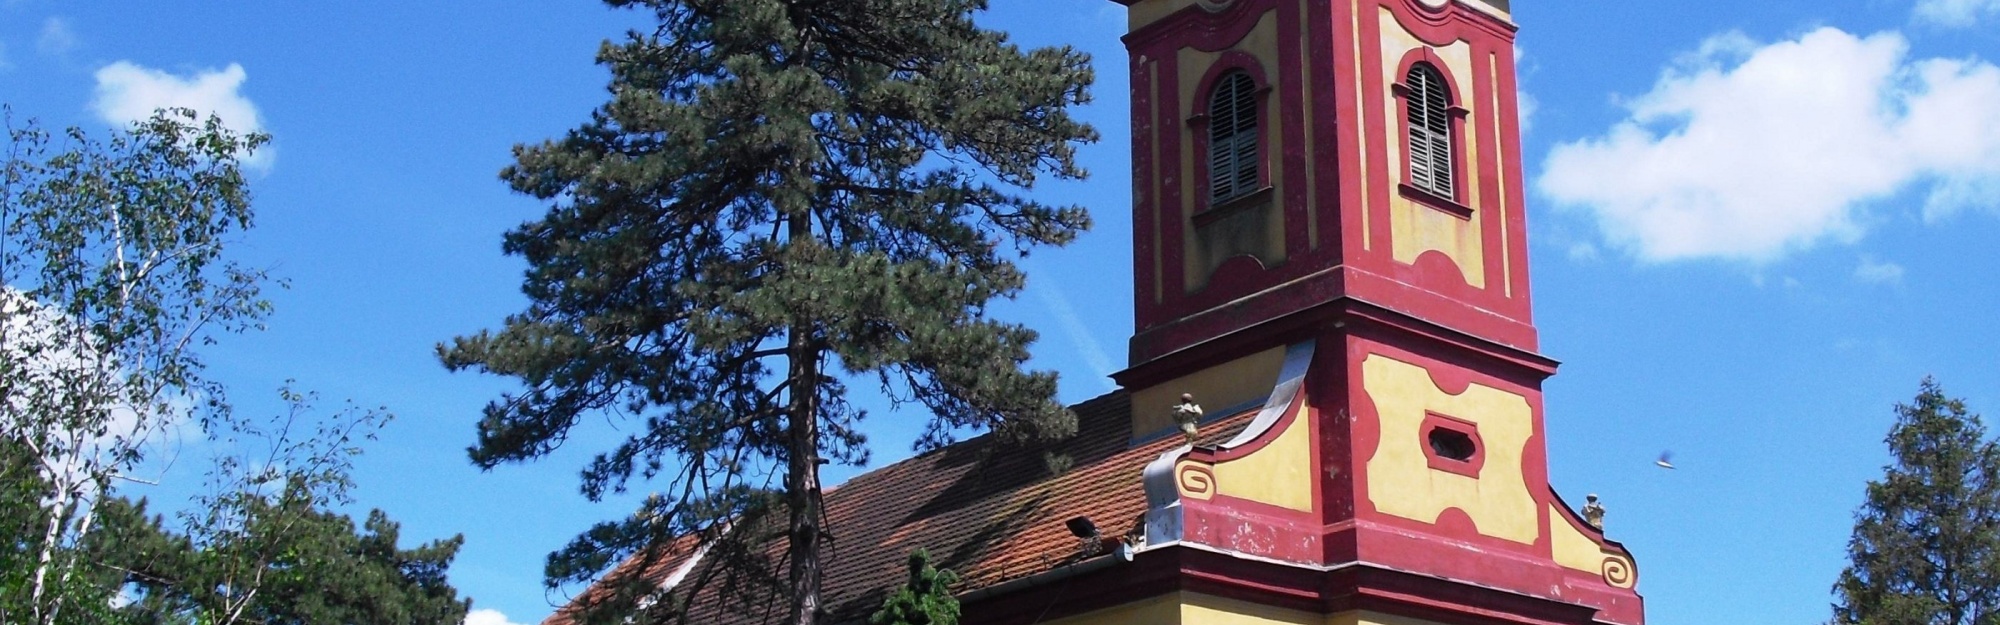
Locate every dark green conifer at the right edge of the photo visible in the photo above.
<box><xmin>1832</xmin><ymin>379</ymin><xmax>2000</xmax><ymax>625</ymax></box>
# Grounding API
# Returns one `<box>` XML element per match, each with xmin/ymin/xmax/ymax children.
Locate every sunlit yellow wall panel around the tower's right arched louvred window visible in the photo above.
<box><xmin>1376</xmin><ymin>6</ymin><xmax>1488</xmax><ymax>288</ymax></box>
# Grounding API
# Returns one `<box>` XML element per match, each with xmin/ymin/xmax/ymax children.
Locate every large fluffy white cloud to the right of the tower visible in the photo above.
<box><xmin>1538</xmin><ymin>28</ymin><xmax>2000</xmax><ymax>262</ymax></box>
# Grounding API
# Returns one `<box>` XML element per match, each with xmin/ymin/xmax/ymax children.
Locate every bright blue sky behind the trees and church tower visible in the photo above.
<box><xmin>0</xmin><ymin>0</ymin><xmax>2000</xmax><ymax>625</ymax></box>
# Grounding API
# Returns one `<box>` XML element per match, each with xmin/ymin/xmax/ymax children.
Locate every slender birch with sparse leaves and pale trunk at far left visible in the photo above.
<box><xmin>0</xmin><ymin>110</ymin><xmax>270</xmax><ymax>623</ymax></box>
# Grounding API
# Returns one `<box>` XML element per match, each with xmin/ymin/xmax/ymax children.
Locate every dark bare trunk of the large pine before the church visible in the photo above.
<box><xmin>784</xmin><ymin>216</ymin><xmax>820</xmax><ymax>625</ymax></box>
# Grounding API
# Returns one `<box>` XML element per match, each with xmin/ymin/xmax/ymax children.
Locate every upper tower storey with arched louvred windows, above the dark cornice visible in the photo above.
<box><xmin>1124</xmin><ymin>0</ymin><xmax>1536</xmax><ymax>363</ymax></box>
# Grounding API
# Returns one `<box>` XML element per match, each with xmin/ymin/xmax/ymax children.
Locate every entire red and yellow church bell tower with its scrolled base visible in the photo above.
<box><xmin>1114</xmin><ymin>0</ymin><xmax>1644</xmax><ymax>625</ymax></box>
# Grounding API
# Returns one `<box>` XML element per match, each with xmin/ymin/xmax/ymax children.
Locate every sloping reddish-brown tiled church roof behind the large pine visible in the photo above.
<box><xmin>544</xmin><ymin>393</ymin><xmax>1248</xmax><ymax>625</ymax></box>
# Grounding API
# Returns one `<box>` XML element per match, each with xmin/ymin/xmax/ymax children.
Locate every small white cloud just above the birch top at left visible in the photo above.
<box><xmin>90</xmin><ymin>60</ymin><xmax>272</xmax><ymax>168</ymax></box>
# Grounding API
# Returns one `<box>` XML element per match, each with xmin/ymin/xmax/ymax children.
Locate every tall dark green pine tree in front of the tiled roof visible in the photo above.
<box><xmin>440</xmin><ymin>0</ymin><xmax>1096</xmax><ymax>623</ymax></box>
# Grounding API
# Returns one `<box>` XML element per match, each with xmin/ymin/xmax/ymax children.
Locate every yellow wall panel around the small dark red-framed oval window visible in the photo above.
<box><xmin>1362</xmin><ymin>355</ymin><xmax>1542</xmax><ymax>543</ymax></box>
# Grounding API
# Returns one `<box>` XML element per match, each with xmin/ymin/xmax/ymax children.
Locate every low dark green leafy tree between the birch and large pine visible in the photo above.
<box><xmin>94</xmin><ymin>389</ymin><xmax>470</xmax><ymax>625</ymax></box>
